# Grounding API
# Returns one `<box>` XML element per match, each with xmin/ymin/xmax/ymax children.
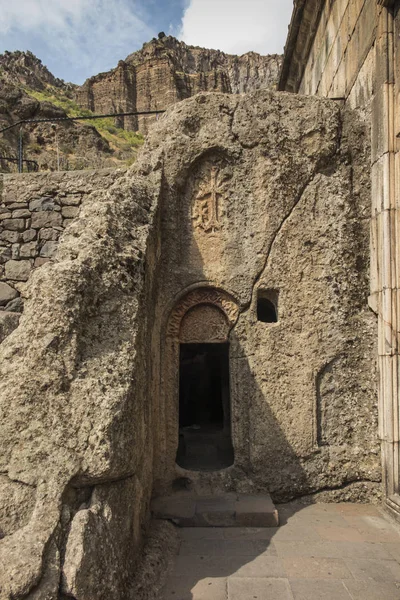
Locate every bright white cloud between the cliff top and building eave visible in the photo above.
<box><xmin>179</xmin><ymin>0</ymin><xmax>293</xmax><ymax>54</ymax></box>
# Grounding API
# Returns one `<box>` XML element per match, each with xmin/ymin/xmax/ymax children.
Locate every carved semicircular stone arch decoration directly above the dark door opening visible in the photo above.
<box><xmin>167</xmin><ymin>287</ymin><xmax>239</xmax><ymax>342</ymax></box>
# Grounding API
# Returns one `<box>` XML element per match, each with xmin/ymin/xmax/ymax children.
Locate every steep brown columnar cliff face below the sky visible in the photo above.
<box><xmin>75</xmin><ymin>34</ymin><xmax>281</xmax><ymax>133</ymax></box>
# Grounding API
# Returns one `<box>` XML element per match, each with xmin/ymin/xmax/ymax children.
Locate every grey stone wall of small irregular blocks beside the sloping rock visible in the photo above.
<box><xmin>0</xmin><ymin>169</ymin><xmax>124</xmax><ymax>312</ymax></box>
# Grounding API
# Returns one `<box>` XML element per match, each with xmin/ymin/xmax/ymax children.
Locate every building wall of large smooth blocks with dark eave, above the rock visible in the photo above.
<box><xmin>279</xmin><ymin>0</ymin><xmax>376</xmax><ymax>119</ymax></box>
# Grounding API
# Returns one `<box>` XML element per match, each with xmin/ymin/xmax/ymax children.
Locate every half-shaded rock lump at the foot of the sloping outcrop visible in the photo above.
<box><xmin>62</xmin><ymin>476</ymin><xmax>146</xmax><ymax>600</ymax></box>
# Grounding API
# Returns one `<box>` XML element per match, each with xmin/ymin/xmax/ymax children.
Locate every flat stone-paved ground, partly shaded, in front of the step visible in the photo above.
<box><xmin>163</xmin><ymin>503</ymin><xmax>400</xmax><ymax>600</ymax></box>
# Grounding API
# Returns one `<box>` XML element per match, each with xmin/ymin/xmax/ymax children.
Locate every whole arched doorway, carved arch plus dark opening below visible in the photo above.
<box><xmin>168</xmin><ymin>288</ymin><xmax>238</xmax><ymax>471</ymax></box>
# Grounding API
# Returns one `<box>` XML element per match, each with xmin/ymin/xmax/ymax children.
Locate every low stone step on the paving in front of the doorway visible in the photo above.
<box><xmin>151</xmin><ymin>492</ymin><xmax>279</xmax><ymax>527</ymax></box>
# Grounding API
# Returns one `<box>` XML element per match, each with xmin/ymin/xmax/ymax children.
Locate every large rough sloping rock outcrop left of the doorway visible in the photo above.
<box><xmin>0</xmin><ymin>157</ymin><xmax>159</xmax><ymax>598</ymax></box>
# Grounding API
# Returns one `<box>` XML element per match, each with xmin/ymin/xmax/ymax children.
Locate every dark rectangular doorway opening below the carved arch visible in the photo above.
<box><xmin>176</xmin><ymin>344</ymin><xmax>233</xmax><ymax>471</ymax></box>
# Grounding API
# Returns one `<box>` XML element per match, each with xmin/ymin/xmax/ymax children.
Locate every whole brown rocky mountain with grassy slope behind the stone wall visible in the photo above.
<box><xmin>0</xmin><ymin>38</ymin><xmax>281</xmax><ymax>171</ymax></box>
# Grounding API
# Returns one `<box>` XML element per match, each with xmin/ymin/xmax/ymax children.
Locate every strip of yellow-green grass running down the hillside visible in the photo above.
<box><xmin>24</xmin><ymin>86</ymin><xmax>144</xmax><ymax>165</ymax></box>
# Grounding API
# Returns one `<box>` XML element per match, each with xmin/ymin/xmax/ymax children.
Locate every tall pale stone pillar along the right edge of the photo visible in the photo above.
<box><xmin>370</xmin><ymin>0</ymin><xmax>400</xmax><ymax>517</ymax></box>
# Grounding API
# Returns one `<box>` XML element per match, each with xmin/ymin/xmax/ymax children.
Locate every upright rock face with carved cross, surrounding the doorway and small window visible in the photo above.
<box><xmin>141</xmin><ymin>92</ymin><xmax>381</xmax><ymax>500</ymax></box>
